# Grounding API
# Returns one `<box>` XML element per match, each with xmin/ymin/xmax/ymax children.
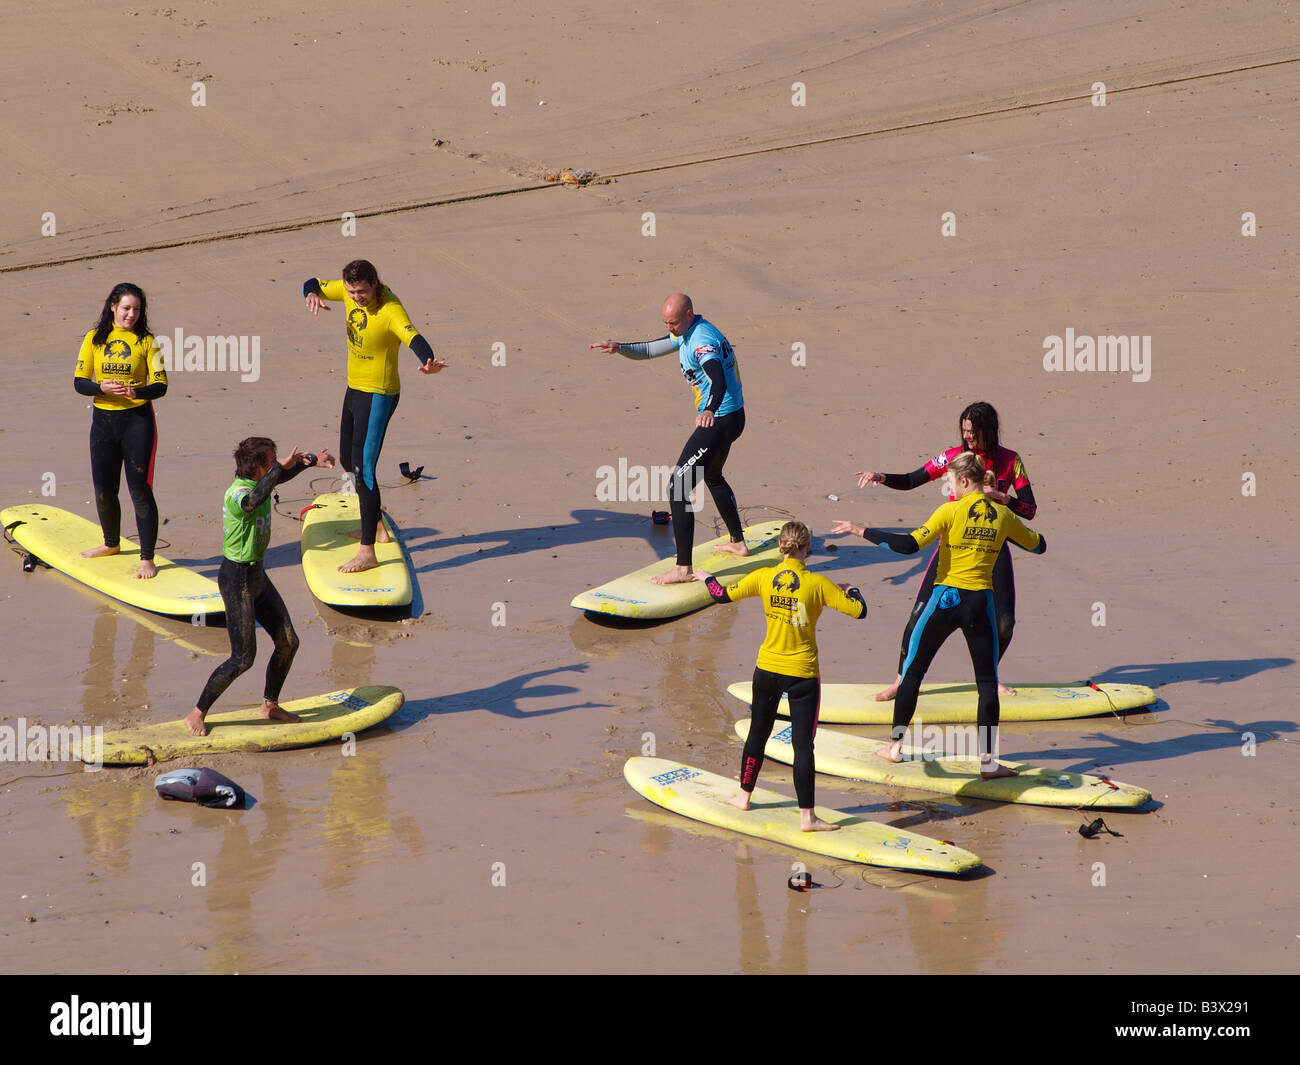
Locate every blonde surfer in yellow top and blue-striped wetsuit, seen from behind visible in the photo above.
<box><xmin>831</xmin><ymin>451</ymin><xmax>1048</xmax><ymax>779</ymax></box>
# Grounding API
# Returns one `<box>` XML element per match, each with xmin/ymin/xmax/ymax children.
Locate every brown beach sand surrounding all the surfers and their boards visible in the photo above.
<box><xmin>0</xmin><ymin>0</ymin><xmax>1300</xmax><ymax>974</ymax></box>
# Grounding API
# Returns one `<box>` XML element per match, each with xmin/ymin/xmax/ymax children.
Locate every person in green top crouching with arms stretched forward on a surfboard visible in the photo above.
<box><xmin>185</xmin><ymin>437</ymin><xmax>334</xmax><ymax>736</ymax></box>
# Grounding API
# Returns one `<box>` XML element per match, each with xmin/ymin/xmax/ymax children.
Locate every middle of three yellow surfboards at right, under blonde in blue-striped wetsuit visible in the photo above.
<box><xmin>736</xmin><ymin>718</ymin><xmax>1151</xmax><ymax>810</ymax></box>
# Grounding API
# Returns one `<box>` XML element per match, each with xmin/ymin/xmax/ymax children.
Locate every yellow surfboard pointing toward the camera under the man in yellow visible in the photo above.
<box><xmin>302</xmin><ymin>492</ymin><xmax>411</xmax><ymax>607</ymax></box>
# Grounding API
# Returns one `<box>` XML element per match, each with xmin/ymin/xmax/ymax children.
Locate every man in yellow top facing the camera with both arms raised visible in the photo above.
<box><xmin>303</xmin><ymin>259</ymin><xmax>447</xmax><ymax>573</ymax></box>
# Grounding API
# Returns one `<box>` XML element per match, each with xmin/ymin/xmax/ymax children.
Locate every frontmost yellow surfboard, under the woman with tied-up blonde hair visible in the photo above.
<box><xmin>623</xmin><ymin>758</ymin><xmax>983</xmax><ymax>874</ymax></box>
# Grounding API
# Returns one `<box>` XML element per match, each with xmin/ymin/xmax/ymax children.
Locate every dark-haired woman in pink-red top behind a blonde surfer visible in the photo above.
<box><xmin>858</xmin><ymin>403</ymin><xmax>1039</xmax><ymax>702</ymax></box>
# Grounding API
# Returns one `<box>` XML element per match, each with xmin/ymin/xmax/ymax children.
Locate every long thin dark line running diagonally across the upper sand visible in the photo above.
<box><xmin>0</xmin><ymin>56</ymin><xmax>1300</xmax><ymax>274</ymax></box>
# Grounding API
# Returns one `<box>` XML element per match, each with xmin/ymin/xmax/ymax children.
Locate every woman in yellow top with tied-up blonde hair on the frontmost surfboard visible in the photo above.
<box><xmin>694</xmin><ymin>521</ymin><xmax>867</xmax><ymax>832</ymax></box>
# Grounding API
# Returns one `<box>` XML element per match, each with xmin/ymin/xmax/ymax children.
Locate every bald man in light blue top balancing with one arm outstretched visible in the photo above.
<box><xmin>590</xmin><ymin>293</ymin><xmax>749</xmax><ymax>584</ymax></box>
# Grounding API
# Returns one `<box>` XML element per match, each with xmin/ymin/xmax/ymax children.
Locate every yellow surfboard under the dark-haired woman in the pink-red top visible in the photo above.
<box><xmin>727</xmin><ymin>680</ymin><xmax>1156</xmax><ymax>724</ymax></box>
